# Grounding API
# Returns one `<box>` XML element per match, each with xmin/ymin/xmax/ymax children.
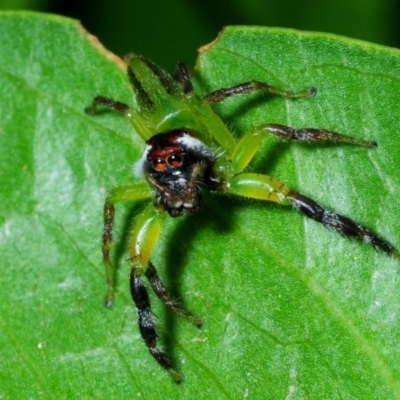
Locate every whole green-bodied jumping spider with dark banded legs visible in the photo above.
<box><xmin>86</xmin><ymin>54</ymin><xmax>400</xmax><ymax>383</ymax></box>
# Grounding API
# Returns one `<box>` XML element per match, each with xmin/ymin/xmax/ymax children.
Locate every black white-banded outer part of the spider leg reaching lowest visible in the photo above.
<box><xmin>130</xmin><ymin>270</ymin><xmax>182</xmax><ymax>383</ymax></box>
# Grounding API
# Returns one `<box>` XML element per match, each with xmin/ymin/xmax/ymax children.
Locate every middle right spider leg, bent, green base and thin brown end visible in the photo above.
<box><xmin>227</xmin><ymin>124</ymin><xmax>377</xmax><ymax>174</ymax></box>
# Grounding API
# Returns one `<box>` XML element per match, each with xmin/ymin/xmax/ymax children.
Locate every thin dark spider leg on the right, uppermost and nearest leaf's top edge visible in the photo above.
<box><xmin>203</xmin><ymin>80</ymin><xmax>317</xmax><ymax>103</ymax></box>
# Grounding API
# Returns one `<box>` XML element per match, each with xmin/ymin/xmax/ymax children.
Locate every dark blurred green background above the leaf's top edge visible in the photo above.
<box><xmin>0</xmin><ymin>0</ymin><xmax>400</xmax><ymax>70</ymax></box>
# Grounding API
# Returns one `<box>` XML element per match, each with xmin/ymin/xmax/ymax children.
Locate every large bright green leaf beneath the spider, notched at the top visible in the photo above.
<box><xmin>0</xmin><ymin>13</ymin><xmax>400</xmax><ymax>399</ymax></box>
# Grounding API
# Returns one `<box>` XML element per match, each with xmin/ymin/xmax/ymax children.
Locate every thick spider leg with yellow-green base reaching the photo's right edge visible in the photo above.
<box><xmin>222</xmin><ymin>173</ymin><xmax>400</xmax><ymax>259</ymax></box>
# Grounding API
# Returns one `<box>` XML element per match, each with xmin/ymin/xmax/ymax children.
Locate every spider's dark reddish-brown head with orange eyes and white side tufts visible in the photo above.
<box><xmin>135</xmin><ymin>129</ymin><xmax>219</xmax><ymax>217</ymax></box>
